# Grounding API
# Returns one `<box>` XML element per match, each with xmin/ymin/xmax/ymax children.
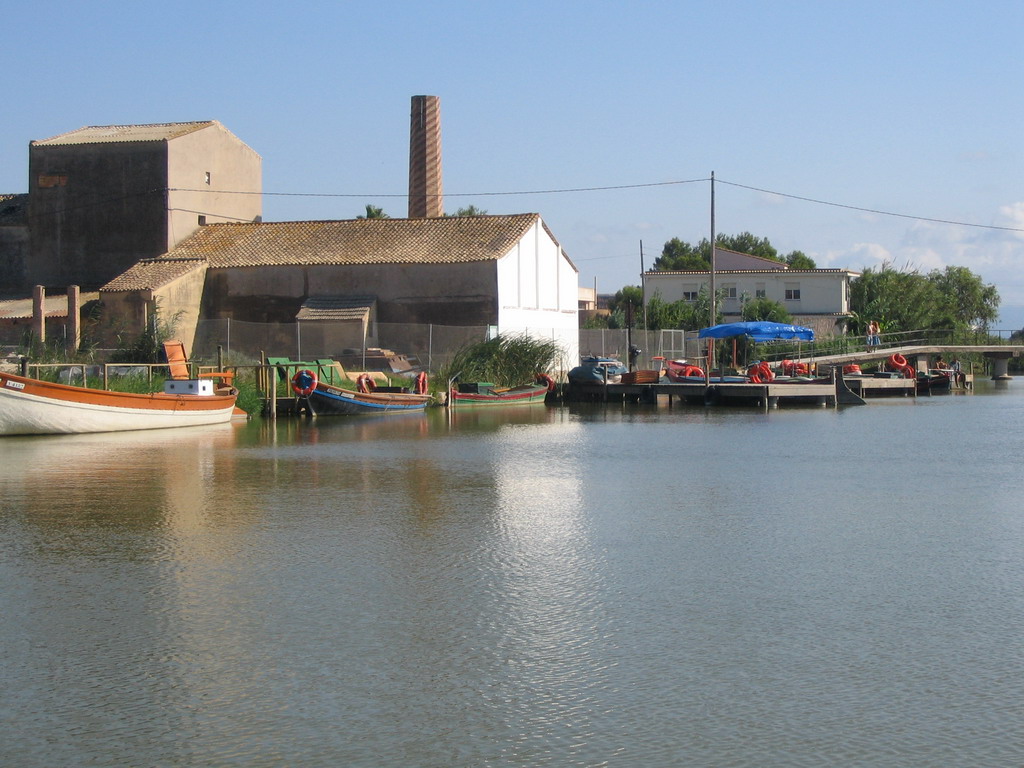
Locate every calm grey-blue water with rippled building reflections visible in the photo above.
<box><xmin>0</xmin><ymin>381</ymin><xmax>1024</xmax><ymax>768</ymax></box>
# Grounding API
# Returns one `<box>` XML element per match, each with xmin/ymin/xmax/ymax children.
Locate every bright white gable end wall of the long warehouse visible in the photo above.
<box><xmin>497</xmin><ymin>219</ymin><xmax>580</xmax><ymax>372</ymax></box>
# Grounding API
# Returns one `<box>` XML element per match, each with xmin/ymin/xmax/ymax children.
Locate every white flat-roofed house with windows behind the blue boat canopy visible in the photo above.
<box><xmin>642</xmin><ymin>248</ymin><xmax>859</xmax><ymax>338</ymax></box>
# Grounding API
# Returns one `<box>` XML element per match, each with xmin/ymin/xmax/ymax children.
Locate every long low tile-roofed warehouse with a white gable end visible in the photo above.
<box><xmin>100</xmin><ymin>213</ymin><xmax>579</xmax><ymax>359</ymax></box>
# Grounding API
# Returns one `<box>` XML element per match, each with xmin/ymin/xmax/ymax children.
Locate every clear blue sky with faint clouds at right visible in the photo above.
<box><xmin>0</xmin><ymin>0</ymin><xmax>1024</xmax><ymax>329</ymax></box>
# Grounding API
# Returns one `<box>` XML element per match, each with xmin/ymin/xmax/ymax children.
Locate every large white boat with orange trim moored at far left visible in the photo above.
<box><xmin>0</xmin><ymin>372</ymin><xmax>238</xmax><ymax>435</ymax></box>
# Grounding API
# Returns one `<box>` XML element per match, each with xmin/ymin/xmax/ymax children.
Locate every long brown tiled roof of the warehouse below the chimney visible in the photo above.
<box><xmin>159</xmin><ymin>213</ymin><xmax>540</xmax><ymax>269</ymax></box>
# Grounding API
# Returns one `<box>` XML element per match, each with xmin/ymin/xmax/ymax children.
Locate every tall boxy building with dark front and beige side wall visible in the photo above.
<box><xmin>27</xmin><ymin>120</ymin><xmax>262</xmax><ymax>291</ymax></box>
